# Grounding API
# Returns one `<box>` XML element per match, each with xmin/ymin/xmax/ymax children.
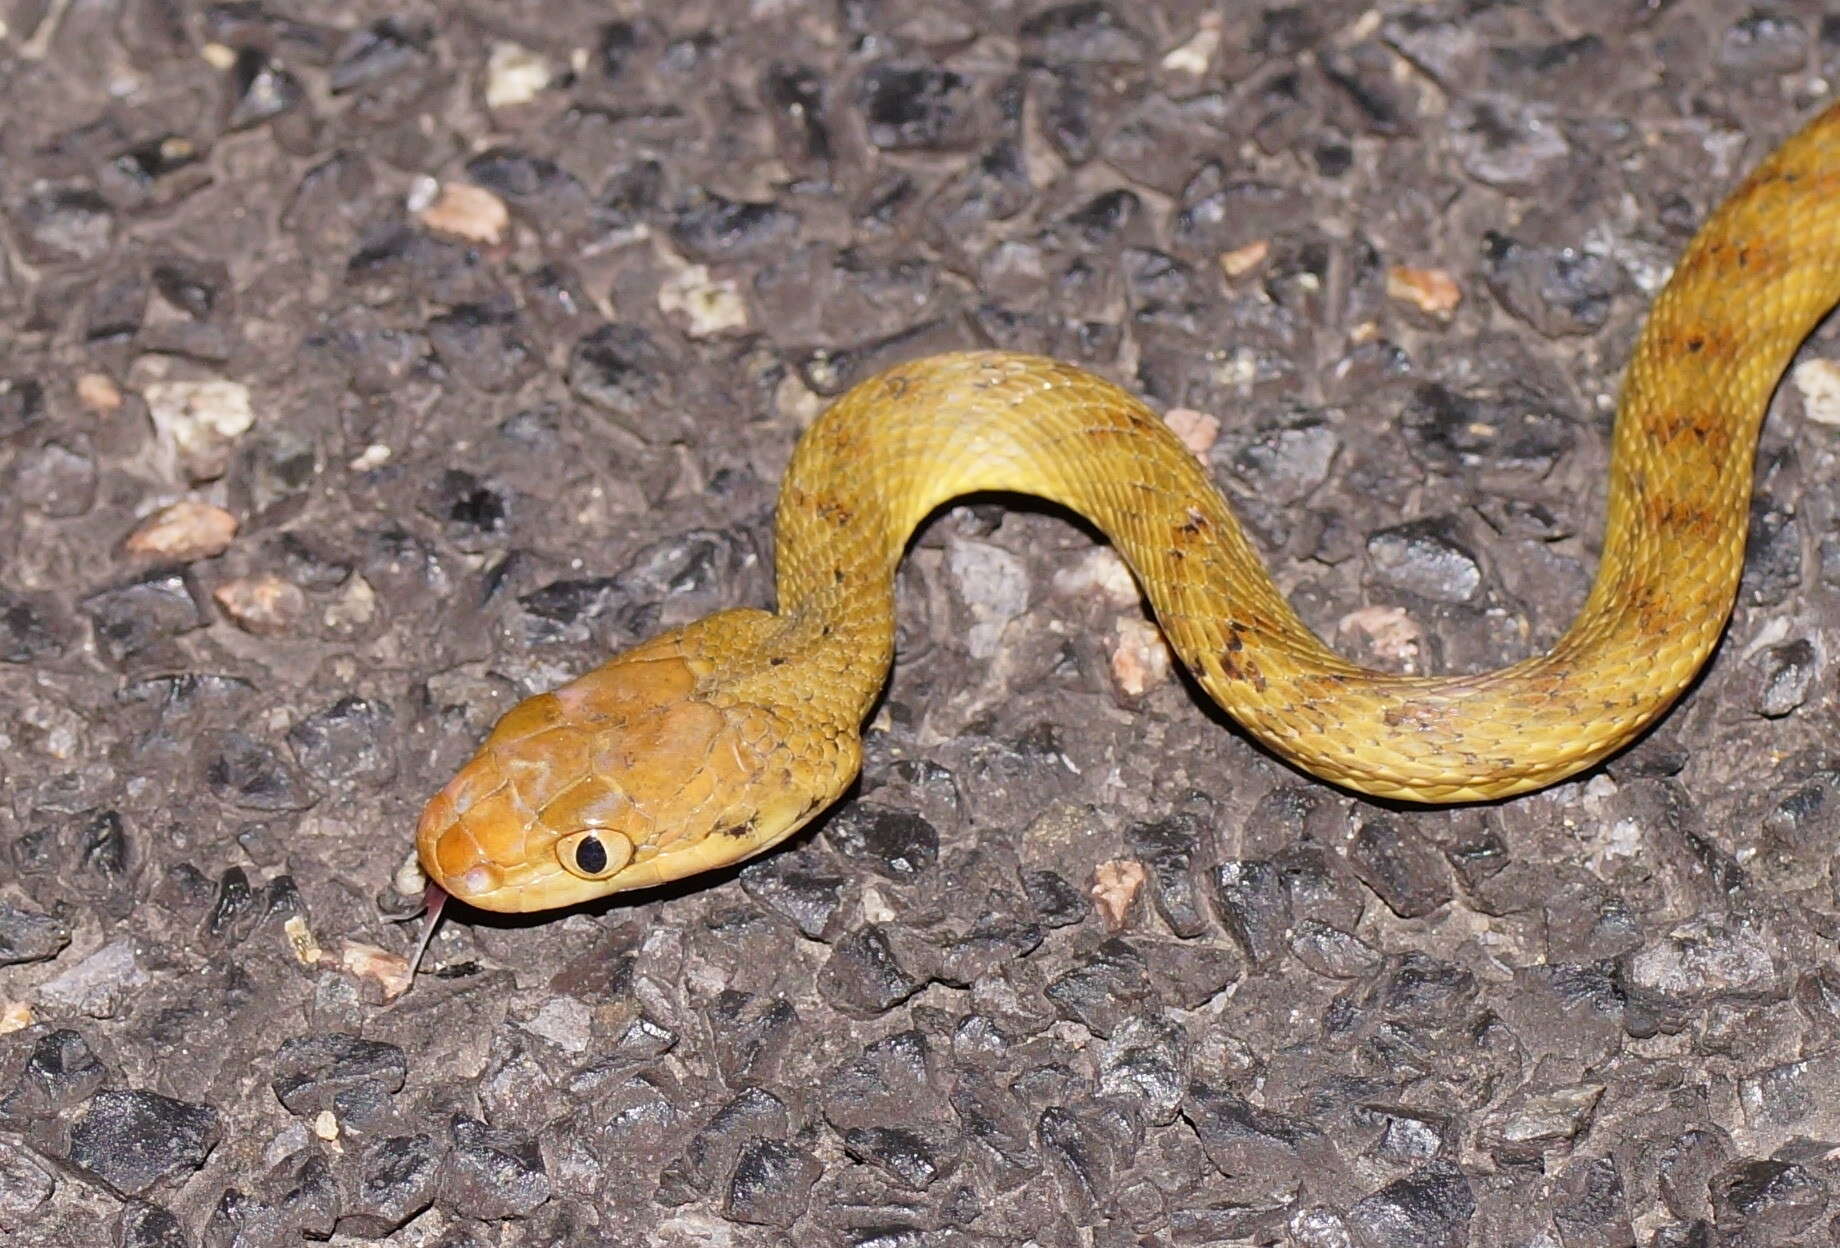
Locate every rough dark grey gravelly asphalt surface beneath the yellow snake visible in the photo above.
<box><xmin>0</xmin><ymin>0</ymin><xmax>1840</xmax><ymax>1248</ymax></box>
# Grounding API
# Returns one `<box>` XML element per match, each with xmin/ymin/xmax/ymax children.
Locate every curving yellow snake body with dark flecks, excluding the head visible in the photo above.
<box><xmin>778</xmin><ymin>97</ymin><xmax>1840</xmax><ymax>803</ymax></box>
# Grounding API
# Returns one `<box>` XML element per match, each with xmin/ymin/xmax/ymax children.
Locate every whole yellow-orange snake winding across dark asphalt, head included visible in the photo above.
<box><xmin>418</xmin><ymin>105</ymin><xmax>1840</xmax><ymax>911</ymax></box>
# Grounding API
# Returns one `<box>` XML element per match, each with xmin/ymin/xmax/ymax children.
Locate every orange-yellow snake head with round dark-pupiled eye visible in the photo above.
<box><xmin>416</xmin><ymin>620</ymin><xmax>859</xmax><ymax>911</ymax></box>
